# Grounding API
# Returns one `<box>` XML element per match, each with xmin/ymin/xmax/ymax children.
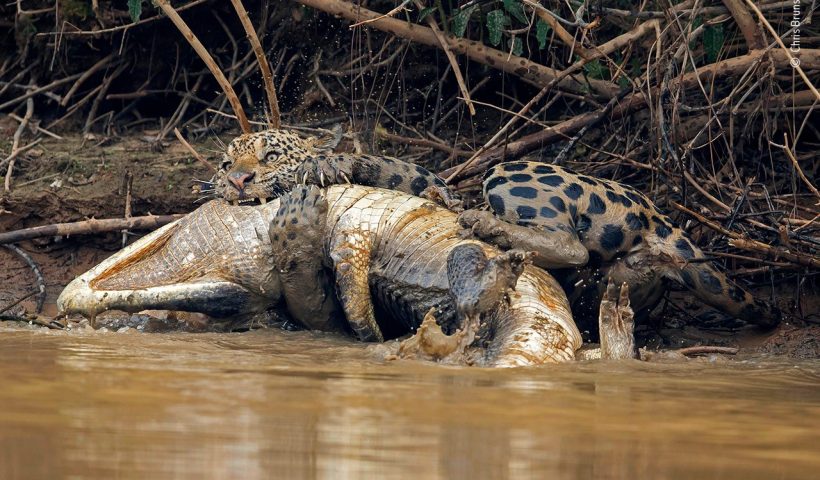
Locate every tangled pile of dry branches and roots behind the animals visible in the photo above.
<box><xmin>0</xmin><ymin>0</ymin><xmax>820</xmax><ymax>316</ymax></box>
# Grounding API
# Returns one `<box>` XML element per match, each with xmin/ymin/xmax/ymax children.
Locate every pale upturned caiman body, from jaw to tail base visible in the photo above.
<box><xmin>58</xmin><ymin>185</ymin><xmax>581</xmax><ymax>366</ymax></box>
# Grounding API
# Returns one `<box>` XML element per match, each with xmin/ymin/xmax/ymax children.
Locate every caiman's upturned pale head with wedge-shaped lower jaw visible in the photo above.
<box><xmin>57</xmin><ymin>200</ymin><xmax>281</xmax><ymax>318</ymax></box>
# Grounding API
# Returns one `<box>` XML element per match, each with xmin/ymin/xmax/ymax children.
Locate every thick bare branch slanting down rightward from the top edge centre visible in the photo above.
<box><xmin>297</xmin><ymin>0</ymin><xmax>619</xmax><ymax>98</ymax></box>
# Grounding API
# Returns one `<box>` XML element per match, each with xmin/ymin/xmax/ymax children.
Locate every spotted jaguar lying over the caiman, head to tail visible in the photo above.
<box><xmin>214</xmin><ymin>130</ymin><xmax>780</xmax><ymax>326</ymax></box>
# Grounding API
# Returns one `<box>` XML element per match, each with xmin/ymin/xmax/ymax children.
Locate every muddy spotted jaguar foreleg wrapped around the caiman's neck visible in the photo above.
<box><xmin>268</xmin><ymin>188</ymin><xmax>344</xmax><ymax>331</ymax></box>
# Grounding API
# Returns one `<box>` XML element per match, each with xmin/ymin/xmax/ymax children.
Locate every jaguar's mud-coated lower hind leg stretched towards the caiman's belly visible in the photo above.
<box><xmin>458</xmin><ymin>210</ymin><xmax>589</xmax><ymax>268</ymax></box>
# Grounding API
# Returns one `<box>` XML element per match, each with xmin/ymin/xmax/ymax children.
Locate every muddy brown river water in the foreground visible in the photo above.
<box><xmin>0</xmin><ymin>328</ymin><xmax>820</xmax><ymax>479</ymax></box>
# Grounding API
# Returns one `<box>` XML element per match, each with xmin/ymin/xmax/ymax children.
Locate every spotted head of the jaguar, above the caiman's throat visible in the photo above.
<box><xmin>211</xmin><ymin>130</ymin><xmax>341</xmax><ymax>205</ymax></box>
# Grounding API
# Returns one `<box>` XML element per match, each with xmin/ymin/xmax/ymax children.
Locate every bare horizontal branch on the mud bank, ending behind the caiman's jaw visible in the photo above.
<box><xmin>0</xmin><ymin>214</ymin><xmax>185</xmax><ymax>245</ymax></box>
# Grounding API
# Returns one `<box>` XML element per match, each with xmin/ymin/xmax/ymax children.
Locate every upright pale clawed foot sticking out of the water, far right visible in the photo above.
<box><xmin>598</xmin><ymin>279</ymin><xmax>638</xmax><ymax>360</ymax></box>
